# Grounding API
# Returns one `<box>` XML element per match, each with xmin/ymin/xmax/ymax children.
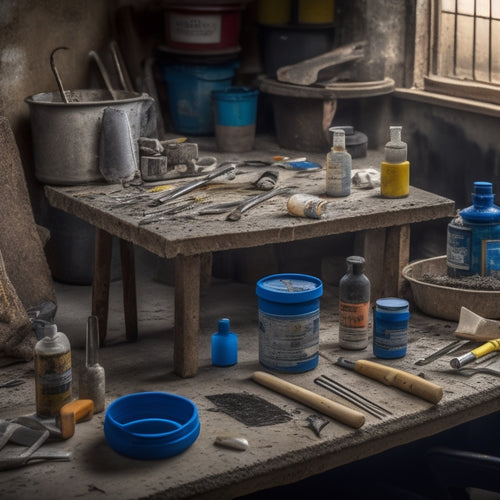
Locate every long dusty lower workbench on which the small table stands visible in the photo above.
<box><xmin>0</xmin><ymin>278</ymin><xmax>500</xmax><ymax>500</ymax></box>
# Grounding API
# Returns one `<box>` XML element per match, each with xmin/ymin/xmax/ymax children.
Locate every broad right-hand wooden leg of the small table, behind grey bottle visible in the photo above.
<box><xmin>354</xmin><ymin>224</ymin><xmax>410</xmax><ymax>302</ymax></box>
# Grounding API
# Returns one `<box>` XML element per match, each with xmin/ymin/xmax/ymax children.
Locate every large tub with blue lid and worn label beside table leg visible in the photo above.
<box><xmin>256</xmin><ymin>274</ymin><xmax>323</xmax><ymax>372</ymax></box>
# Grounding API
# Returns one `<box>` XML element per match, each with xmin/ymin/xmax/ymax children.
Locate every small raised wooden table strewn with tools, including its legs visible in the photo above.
<box><xmin>45</xmin><ymin>138</ymin><xmax>454</xmax><ymax>377</ymax></box>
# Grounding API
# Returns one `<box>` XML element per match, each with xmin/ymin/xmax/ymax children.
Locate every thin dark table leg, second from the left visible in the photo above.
<box><xmin>120</xmin><ymin>239</ymin><xmax>138</xmax><ymax>342</ymax></box>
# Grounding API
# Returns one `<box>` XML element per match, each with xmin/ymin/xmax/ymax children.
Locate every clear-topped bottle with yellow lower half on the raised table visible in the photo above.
<box><xmin>380</xmin><ymin>126</ymin><xmax>410</xmax><ymax>198</ymax></box>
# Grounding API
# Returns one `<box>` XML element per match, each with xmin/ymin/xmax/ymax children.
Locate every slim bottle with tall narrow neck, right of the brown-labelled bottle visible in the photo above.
<box><xmin>78</xmin><ymin>316</ymin><xmax>105</xmax><ymax>413</ymax></box>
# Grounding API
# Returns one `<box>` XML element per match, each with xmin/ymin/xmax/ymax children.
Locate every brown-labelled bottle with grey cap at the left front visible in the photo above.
<box><xmin>33</xmin><ymin>323</ymin><xmax>72</xmax><ymax>417</ymax></box>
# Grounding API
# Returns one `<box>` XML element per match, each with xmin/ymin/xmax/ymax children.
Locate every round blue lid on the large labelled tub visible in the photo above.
<box><xmin>256</xmin><ymin>273</ymin><xmax>323</xmax><ymax>304</ymax></box>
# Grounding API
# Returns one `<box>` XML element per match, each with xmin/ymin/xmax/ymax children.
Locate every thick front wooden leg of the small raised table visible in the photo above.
<box><xmin>174</xmin><ymin>255</ymin><xmax>201</xmax><ymax>377</ymax></box>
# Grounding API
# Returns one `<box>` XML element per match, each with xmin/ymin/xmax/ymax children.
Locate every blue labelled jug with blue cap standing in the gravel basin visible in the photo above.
<box><xmin>446</xmin><ymin>181</ymin><xmax>500</xmax><ymax>278</ymax></box>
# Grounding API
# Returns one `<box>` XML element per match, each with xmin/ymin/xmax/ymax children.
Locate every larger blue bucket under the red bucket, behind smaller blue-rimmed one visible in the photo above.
<box><xmin>163</xmin><ymin>62</ymin><xmax>236</xmax><ymax>135</ymax></box>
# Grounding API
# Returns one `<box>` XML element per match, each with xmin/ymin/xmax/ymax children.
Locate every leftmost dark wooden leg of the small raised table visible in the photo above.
<box><xmin>92</xmin><ymin>228</ymin><xmax>113</xmax><ymax>346</ymax></box>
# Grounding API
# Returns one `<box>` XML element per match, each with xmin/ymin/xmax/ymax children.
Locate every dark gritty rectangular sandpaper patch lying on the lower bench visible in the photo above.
<box><xmin>207</xmin><ymin>393</ymin><xmax>292</xmax><ymax>427</ymax></box>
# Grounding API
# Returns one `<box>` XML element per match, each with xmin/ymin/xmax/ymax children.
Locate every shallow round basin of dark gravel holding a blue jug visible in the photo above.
<box><xmin>403</xmin><ymin>255</ymin><xmax>500</xmax><ymax>322</ymax></box>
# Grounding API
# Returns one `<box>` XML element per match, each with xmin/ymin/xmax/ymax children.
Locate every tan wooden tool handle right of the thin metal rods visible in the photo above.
<box><xmin>355</xmin><ymin>359</ymin><xmax>443</xmax><ymax>404</ymax></box>
